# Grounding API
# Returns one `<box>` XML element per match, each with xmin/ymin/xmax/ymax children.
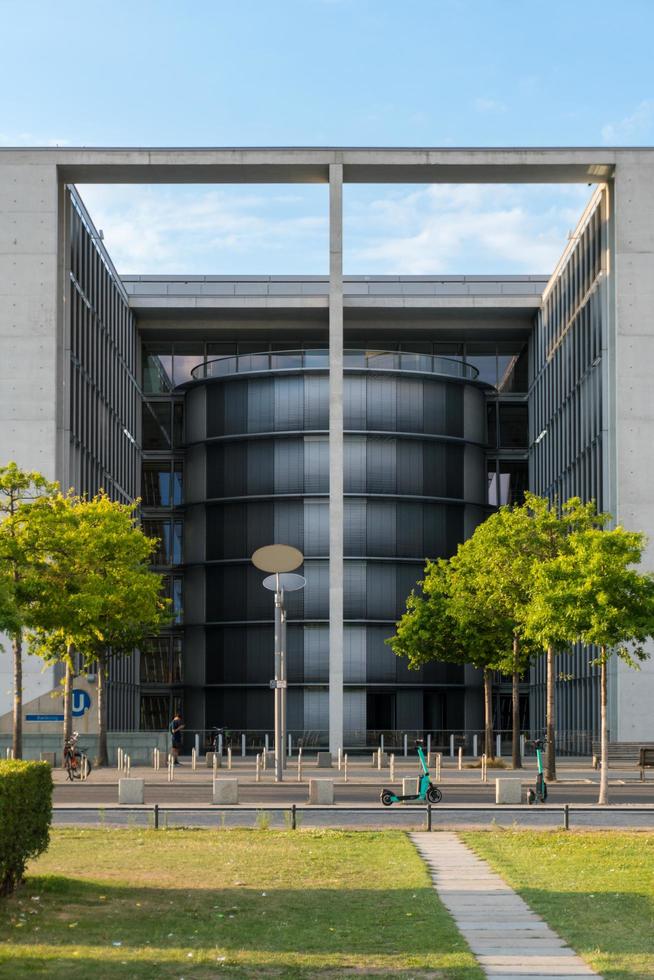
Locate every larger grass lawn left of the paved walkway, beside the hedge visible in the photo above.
<box><xmin>0</xmin><ymin>828</ymin><xmax>483</xmax><ymax>980</ymax></box>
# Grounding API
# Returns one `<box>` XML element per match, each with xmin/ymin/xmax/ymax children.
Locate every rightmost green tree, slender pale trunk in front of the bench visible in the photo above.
<box><xmin>531</xmin><ymin>527</ymin><xmax>654</xmax><ymax>804</ymax></box>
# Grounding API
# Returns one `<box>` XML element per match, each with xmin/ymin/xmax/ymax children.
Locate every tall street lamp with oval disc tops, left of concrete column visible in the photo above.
<box><xmin>252</xmin><ymin>544</ymin><xmax>305</xmax><ymax>782</ymax></box>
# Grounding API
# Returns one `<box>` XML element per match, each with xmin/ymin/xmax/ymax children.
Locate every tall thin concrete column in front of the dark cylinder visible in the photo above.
<box><xmin>329</xmin><ymin>163</ymin><xmax>343</xmax><ymax>753</ymax></box>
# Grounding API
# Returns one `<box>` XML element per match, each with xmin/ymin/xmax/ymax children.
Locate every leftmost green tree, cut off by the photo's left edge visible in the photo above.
<box><xmin>0</xmin><ymin>462</ymin><xmax>57</xmax><ymax>759</ymax></box>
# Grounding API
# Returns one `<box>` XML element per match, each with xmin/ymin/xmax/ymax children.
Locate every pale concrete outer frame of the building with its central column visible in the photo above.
<box><xmin>0</xmin><ymin>147</ymin><xmax>654</xmax><ymax>751</ymax></box>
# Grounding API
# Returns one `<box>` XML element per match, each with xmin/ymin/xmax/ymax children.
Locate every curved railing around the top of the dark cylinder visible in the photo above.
<box><xmin>191</xmin><ymin>349</ymin><xmax>479</xmax><ymax>381</ymax></box>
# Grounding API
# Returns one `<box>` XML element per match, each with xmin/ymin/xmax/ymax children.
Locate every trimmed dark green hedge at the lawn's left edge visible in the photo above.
<box><xmin>0</xmin><ymin>759</ymin><xmax>52</xmax><ymax>895</ymax></box>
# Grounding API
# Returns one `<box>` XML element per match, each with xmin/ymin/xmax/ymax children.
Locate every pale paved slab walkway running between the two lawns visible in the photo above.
<box><xmin>411</xmin><ymin>833</ymin><xmax>598</xmax><ymax>980</ymax></box>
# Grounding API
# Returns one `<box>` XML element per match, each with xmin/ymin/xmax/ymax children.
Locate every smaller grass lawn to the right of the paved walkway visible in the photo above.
<box><xmin>461</xmin><ymin>831</ymin><xmax>654</xmax><ymax>980</ymax></box>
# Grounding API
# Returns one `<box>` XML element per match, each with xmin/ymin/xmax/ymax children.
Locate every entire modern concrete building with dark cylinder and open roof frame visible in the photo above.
<box><xmin>0</xmin><ymin>148</ymin><xmax>654</xmax><ymax>750</ymax></box>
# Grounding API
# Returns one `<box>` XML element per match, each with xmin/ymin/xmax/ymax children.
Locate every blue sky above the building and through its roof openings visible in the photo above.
<box><xmin>0</xmin><ymin>0</ymin><xmax>654</xmax><ymax>274</ymax></box>
